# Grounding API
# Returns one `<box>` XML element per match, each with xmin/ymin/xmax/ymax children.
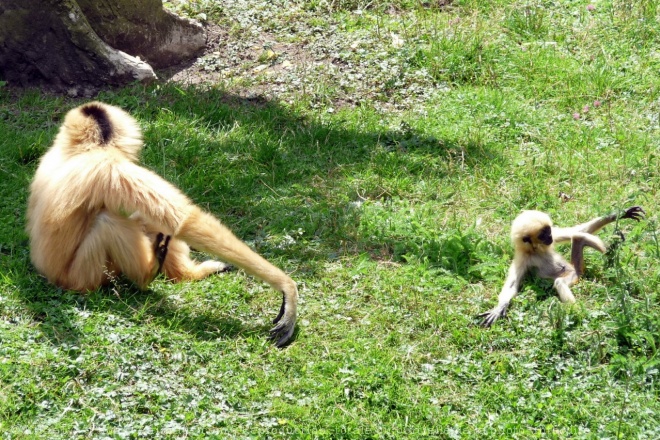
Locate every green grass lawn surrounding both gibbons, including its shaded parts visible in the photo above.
<box><xmin>0</xmin><ymin>0</ymin><xmax>660</xmax><ymax>439</ymax></box>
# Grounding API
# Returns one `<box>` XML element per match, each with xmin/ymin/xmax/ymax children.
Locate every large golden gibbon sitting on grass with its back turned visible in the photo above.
<box><xmin>27</xmin><ymin>102</ymin><xmax>298</xmax><ymax>346</ymax></box>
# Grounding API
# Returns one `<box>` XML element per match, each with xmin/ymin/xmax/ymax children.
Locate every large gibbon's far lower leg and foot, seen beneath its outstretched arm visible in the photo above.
<box><xmin>163</xmin><ymin>238</ymin><xmax>231</xmax><ymax>281</ymax></box>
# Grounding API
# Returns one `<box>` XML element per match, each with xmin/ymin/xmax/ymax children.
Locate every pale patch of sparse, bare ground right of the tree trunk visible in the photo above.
<box><xmin>161</xmin><ymin>0</ymin><xmax>456</xmax><ymax>112</ymax></box>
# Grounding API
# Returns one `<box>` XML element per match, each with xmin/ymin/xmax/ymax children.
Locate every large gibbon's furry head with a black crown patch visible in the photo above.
<box><xmin>54</xmin><ymin>101</ymin><xmax>142</xmax><ymax>161</ymax></box>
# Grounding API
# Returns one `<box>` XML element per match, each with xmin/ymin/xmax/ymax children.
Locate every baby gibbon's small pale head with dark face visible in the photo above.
<box><xmin>511</xmin><ymin>211</ymin><xmax>552</xmax><ymax>254</ymax></box>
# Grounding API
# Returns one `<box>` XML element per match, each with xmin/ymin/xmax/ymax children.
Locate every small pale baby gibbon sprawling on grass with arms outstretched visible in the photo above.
<box><xmin>479</xmin><ymin>206</ymin><xmax>644</xmax><ymax>327</ymax></box>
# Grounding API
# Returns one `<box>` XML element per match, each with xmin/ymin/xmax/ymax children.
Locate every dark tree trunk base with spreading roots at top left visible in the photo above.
<box><xmin>0</xmin><ymin>0</ymin><xmax>206</xmax><ymax>95</ymax></box>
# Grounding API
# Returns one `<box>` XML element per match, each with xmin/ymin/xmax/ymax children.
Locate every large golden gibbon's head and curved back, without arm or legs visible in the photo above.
<box><xmin>27</xmin><ymin>102</ymin><xmax>142</xmax><ymax>283</ymax></box>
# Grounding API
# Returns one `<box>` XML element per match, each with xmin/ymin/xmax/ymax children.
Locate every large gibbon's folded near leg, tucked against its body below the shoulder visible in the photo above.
<box><xmin>62</xmin><ymin>212</ymin><xmax>167</xmax><ymax>290</ymax></box>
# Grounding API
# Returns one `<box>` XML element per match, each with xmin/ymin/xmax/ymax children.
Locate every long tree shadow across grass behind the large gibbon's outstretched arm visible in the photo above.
<box><xmin>126</xmin><ymin>83</ymin><xmax>499</xmax><ymax>273</ymax></box>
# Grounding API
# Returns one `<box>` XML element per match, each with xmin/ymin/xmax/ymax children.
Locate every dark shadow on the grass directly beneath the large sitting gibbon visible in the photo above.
<box><xmin>7</xmin><ymin>249</ymin><xmax>276</xmax><ymax>346</ymax></box>
